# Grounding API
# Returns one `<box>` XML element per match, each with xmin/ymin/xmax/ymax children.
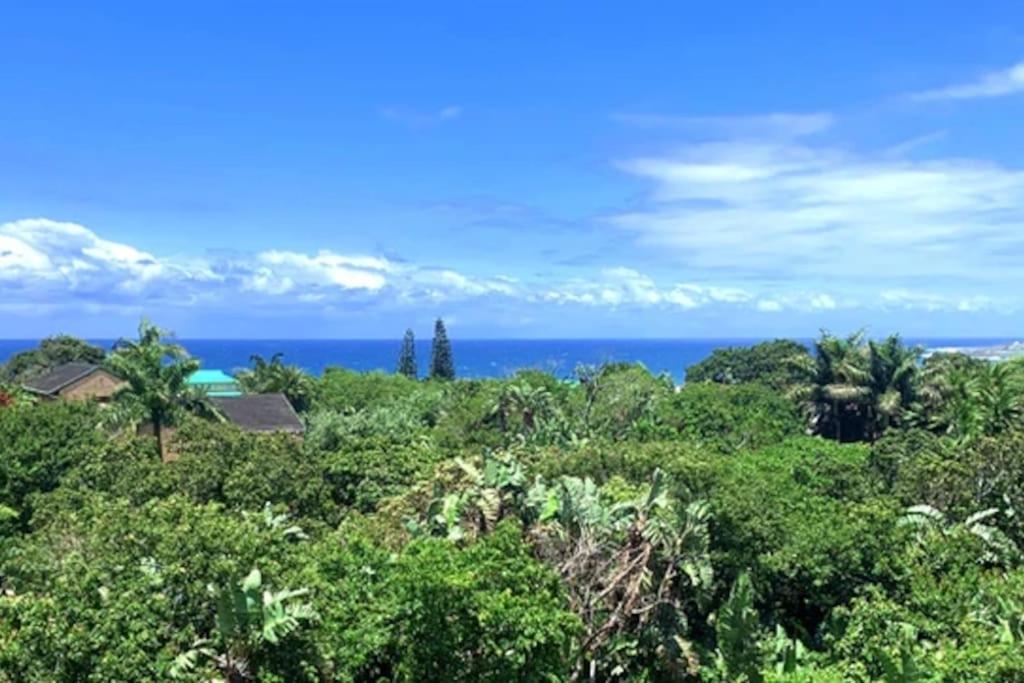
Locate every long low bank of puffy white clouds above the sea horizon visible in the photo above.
<box><xmin>0</xmin><ymin>218</ymin><xmax>1011</xmax><ymax>314</ymax></box>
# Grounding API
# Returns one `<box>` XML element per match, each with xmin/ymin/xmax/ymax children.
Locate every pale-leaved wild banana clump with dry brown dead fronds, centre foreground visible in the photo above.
<box><xmin>411</xmin><ymin>456</ymin><xmax>713</xmax><ymax>677</ymax></box>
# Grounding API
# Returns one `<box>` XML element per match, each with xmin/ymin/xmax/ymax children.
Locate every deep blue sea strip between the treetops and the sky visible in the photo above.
<box><xmin>0</xmin><ymin>339</ymin><xmax>1013</xmax><ymax>383</ymax></box>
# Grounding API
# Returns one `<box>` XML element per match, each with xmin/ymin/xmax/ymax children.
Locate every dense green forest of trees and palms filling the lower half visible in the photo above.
<box><xmin>0</xmin><ymin>324</ymin><xmax>1024</xmax><ymax>683</ymax></box>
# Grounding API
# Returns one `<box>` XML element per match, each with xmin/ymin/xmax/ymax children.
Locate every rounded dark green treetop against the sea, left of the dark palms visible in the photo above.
<box><xmin>686</xmin><ymin>339</ymin><xmax>810</xmax><ymax>390</ymax></box>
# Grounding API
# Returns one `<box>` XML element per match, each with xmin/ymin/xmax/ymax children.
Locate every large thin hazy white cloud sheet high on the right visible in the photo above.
<box><xmin>608</xmin><ymin>142</ymin><xmax>1024</xmax><ymax>290</ymax></box>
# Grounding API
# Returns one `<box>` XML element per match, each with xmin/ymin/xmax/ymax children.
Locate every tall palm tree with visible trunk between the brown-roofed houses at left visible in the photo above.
<box><xmin>106</xmin><ymin>318</ymin><xmax>204</xmax><ymax>456</ymax></box>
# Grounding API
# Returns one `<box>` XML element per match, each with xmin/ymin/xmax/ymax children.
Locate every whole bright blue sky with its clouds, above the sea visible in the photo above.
<box><xmin>0</xmin><ymin>2</ymin><xmax>1024</xmax><ymax>338</ymax></box>
